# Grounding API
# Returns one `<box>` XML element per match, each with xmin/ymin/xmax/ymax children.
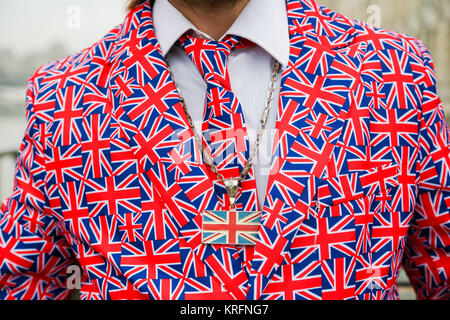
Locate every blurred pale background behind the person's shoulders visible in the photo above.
<box><xmin>0</xmin><ymin>0</ymin><xmax>450</xmax><ymax>299</ymax></box>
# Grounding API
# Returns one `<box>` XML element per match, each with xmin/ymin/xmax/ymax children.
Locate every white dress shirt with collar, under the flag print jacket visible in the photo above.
<box><xmin>153</xmin><ymin>0</ymin><xmax>289</xmax><ymax>208</ymax></box>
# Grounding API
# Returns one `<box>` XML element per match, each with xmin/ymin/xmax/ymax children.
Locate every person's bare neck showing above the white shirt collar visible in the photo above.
<box><xmin>169</xmin><ymin>0</ymin><xmax>250</xmax><ymax>40</ymax></box>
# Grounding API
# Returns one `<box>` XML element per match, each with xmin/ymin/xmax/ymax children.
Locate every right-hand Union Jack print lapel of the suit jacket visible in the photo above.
<box><xmin>247</xmin><ymin>0</ymin><xmax>365</xmax><ymax>299</ymax></box>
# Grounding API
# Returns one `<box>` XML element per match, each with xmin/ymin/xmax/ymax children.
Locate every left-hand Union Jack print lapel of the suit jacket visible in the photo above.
<box><xmin>106</xmin><ymin>4</ymin><xmax>253</xmax><ymax>299</ymax></box>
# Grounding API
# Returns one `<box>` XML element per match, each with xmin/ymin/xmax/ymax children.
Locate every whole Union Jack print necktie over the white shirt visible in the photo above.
<box><xmin>180</xmin><ymin>34</ymin><xmax>258</xmax><ymax>210</ymax></box>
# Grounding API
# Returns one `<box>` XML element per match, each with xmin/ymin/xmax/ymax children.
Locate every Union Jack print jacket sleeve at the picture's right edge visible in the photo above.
<box><xmin>403</xmin><ymin>42</ymin><xmax>450</xmax><ymax>300</ymax></box>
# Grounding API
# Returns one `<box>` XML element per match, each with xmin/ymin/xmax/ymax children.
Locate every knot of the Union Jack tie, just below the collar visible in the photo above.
<box><xmin>180</xmin><ymin>34</ymin><xmax>245</xmax><ymax>88</ymax></box>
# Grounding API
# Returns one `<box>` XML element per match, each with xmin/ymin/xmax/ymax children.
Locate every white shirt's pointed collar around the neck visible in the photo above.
<box><xmin>153</xmin><ymin>0</ymin><xmax>290</xmax><ymax>67</ymax></box>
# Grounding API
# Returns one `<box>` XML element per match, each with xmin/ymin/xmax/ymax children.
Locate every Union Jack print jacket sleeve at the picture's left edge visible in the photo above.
<box><xmin>0</xmin><ymin>75</ymin><xmax>75</xmax><ymax>300</ymax></box>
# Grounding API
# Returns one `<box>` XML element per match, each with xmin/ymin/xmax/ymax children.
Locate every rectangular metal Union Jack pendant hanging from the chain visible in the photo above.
<box><xmin>202</xmin><ymin>210</ymin><xmax>262</xmax><ymax>246</ymax></box>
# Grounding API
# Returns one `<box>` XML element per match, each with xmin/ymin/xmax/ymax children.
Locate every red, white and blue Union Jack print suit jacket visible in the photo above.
<box><xmin>0</xmin><ymin>0</ymin><xmax>450</xmax><ymax>299</ymax></box>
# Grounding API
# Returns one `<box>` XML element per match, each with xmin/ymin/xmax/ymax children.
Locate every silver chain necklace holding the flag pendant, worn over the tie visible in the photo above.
<box><xmin>165</xmin><ymin>59</ymin><xmax>281</xmax><ymax>208</ymax></box>
